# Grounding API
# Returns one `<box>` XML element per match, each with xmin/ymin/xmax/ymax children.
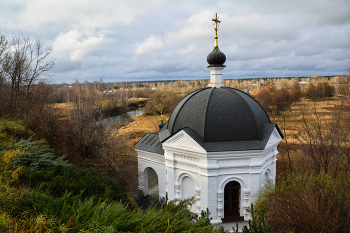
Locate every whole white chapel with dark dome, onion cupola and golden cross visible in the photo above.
<box><xmin>134</xmin><ymin>15</ymin><xmax>283</xmax><ymax>228</ymax></box>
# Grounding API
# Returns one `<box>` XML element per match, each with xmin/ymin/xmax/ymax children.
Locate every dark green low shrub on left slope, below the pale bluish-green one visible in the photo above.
<box><xmin>19</xmin><ymin>165</ymin><xmax>125</xmax><ymax>200</ymax></box>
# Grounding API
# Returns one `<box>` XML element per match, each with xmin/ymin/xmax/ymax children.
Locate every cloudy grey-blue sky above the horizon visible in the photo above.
<box><xmin>0</xmin><ymin>0</ymin><xmax>350</xmax><ymax>83</ymax></box>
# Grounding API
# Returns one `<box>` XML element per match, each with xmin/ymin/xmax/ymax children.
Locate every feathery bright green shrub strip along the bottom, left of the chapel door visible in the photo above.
<box><xmin>0</xmin><ymin>192</ymin><xmax>223</xmax><ymax>232</ymax></box>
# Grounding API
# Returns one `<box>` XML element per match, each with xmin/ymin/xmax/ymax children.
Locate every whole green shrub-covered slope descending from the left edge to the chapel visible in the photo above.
<box><xmin>0</xmin><ymin>119</ymin><xmax>222</xmax><ymax>232</ymax></box>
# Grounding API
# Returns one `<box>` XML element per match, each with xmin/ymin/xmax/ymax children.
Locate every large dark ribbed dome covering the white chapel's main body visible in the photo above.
<box><xmin>159</xmin><ymin>87</ymin><xmax>271</xmax><ymax>143</ymax></box>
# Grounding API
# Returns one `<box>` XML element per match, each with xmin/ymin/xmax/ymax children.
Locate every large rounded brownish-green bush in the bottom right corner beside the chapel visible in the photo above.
<box><xmin>257</xmin><ymin>173</ymin><xmax>350</xmax><ymax>233</ymax></box>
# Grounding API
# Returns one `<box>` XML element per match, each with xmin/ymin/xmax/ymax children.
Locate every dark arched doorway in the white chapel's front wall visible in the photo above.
<box><xmin>222</xmin><ymin>181</ymin><xmax>244</xmax><ymax>222</ymax></box>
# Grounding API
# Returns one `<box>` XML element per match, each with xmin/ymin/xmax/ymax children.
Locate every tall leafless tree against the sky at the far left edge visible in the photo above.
<box><xmin>1</xmin><ymin>33</ymin><xmax>54</xmax><ymax>117</ymax></box>
